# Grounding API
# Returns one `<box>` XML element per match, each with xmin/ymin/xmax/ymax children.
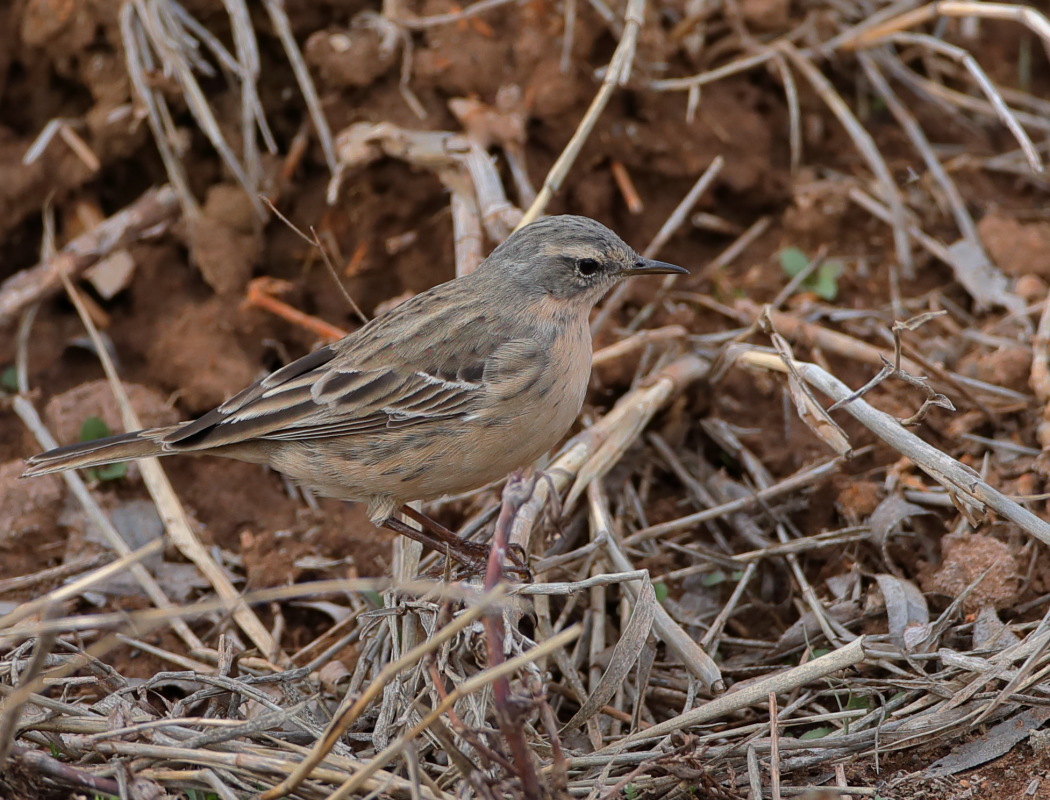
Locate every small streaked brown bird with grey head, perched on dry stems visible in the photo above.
<box><xmin>25</xmin><ymin>215</ymin><xmax>688</xmax><ymax>567</ymax></box>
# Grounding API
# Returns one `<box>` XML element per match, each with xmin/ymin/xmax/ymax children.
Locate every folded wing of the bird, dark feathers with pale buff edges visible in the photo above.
<box><xmin>161</xmin><ymin>338</ymin><xmax>513</xmax><ymax>450</ymax></box>
